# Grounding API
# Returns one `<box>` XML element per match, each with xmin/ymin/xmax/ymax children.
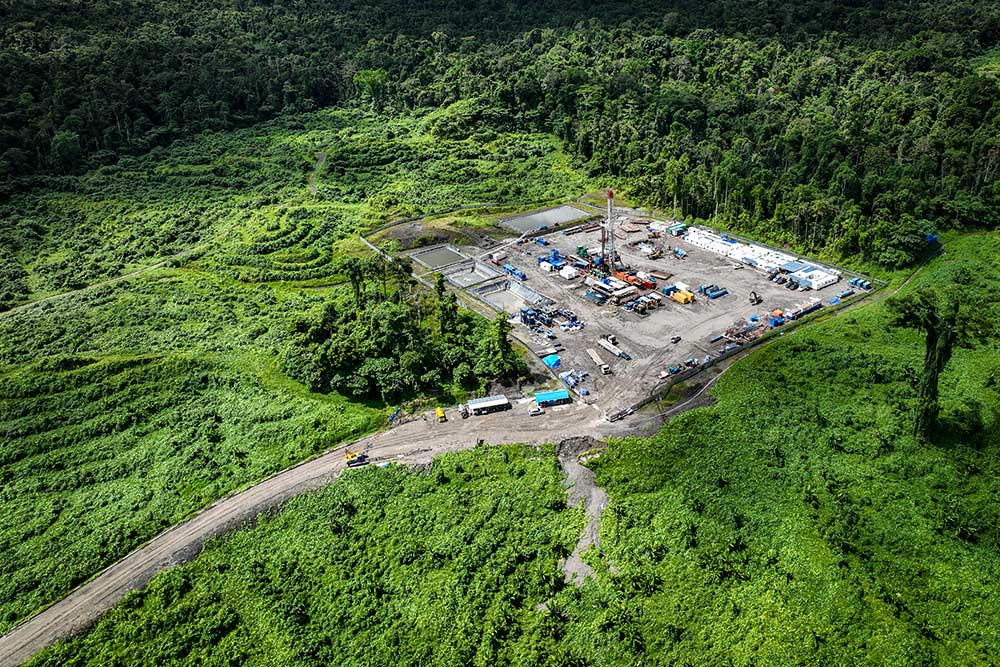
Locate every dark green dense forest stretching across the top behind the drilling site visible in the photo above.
<box><xmin>0</xmin><ymin>0</ymin><xmax>1000</xmax><ymax>268</ymax></box>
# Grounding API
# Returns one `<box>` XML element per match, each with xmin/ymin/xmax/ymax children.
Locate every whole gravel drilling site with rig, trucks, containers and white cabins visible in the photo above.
<box><xmin>402</xmin><ymin>197</ymin><xmax>873</xmax><ymax>415</ymax></box>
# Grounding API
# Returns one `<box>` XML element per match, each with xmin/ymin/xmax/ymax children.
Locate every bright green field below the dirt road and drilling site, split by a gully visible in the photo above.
<box><xmin>25</xmin><ymin>233</ymin><xmax>1000</xmax><ymax>667</ymax></box>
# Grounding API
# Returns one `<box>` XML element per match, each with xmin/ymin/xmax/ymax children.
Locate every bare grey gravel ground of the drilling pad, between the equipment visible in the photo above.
<box><xmin>411</xmin><ymin>207</ymin><xmax>864</xmax><ymax>415</ymax></box>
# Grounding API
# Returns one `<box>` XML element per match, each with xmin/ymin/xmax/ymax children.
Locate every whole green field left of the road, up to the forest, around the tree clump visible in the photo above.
<box><xmin>0</xmin><ymin>110</ymin><xmax>581</xmax><ymax>632</ymax></box>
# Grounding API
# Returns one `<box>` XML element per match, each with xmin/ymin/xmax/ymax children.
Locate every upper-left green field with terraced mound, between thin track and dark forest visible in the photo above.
<box><xmin>0</xmin><ymin>108</ymin><xmax>585</xmax><ymax>308</ymax></box>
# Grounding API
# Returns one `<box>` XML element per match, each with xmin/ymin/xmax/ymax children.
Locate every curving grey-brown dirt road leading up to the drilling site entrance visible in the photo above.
<box><xmin>0</xmin><ymin>403</ymin><xmax>634</xmax><ymax>667</ymax></box>
